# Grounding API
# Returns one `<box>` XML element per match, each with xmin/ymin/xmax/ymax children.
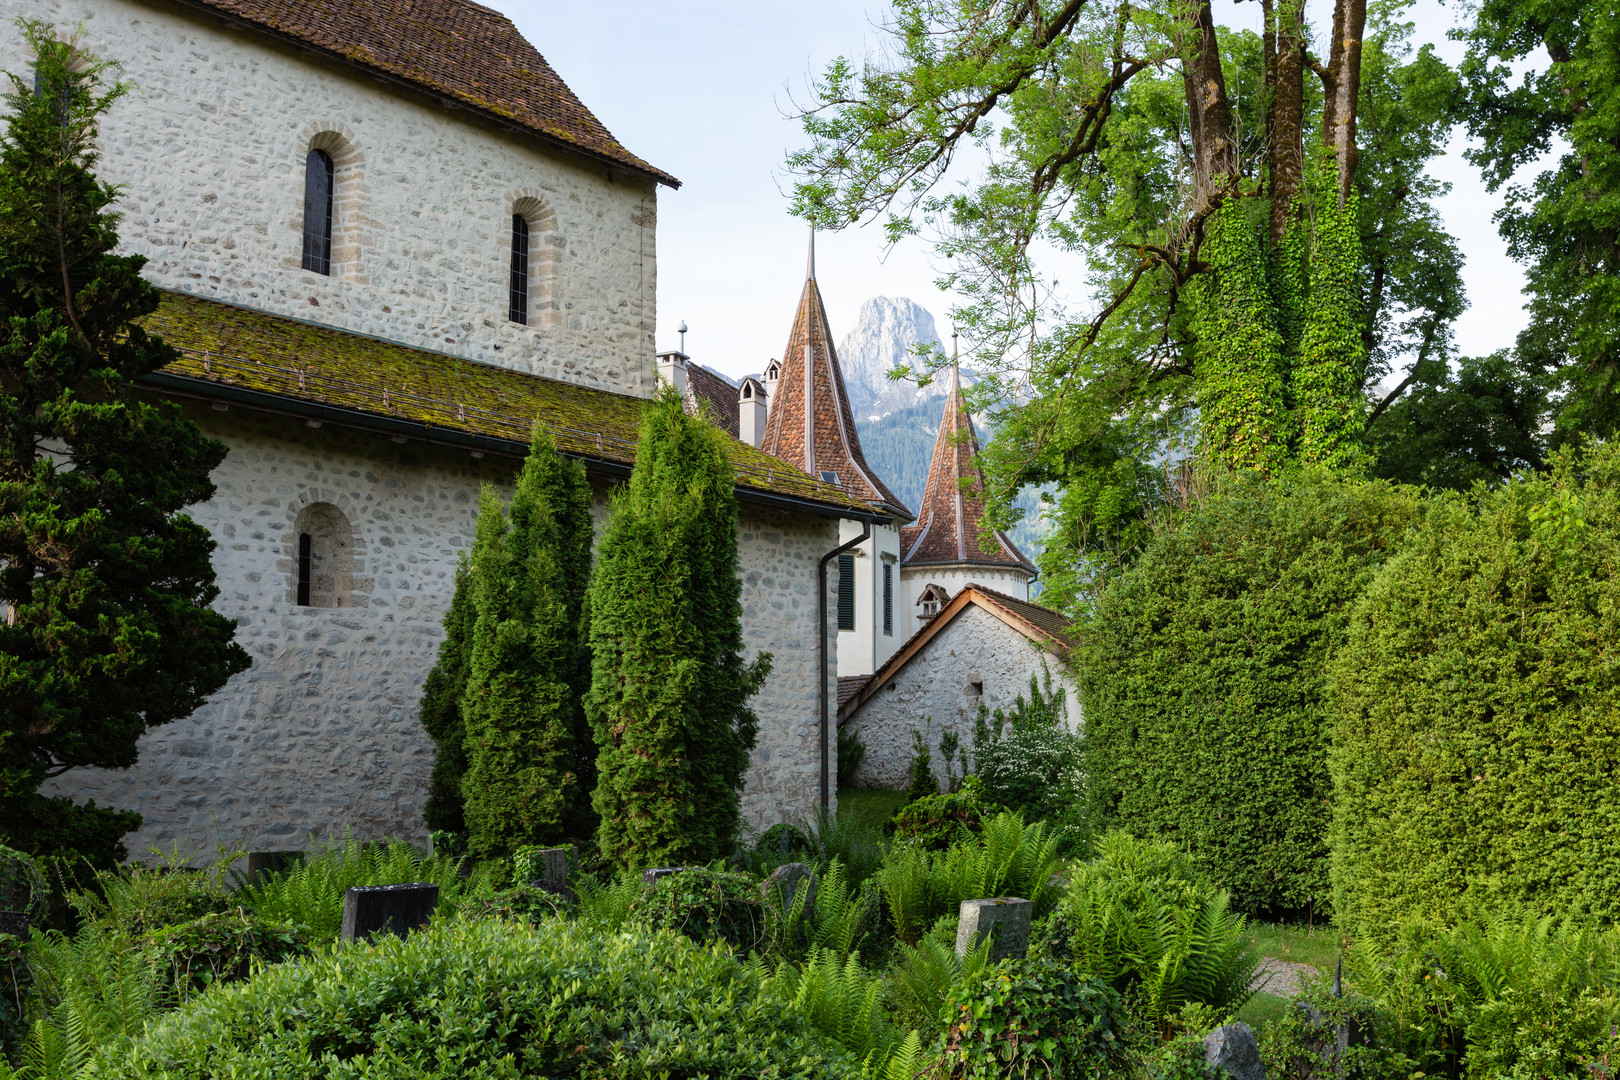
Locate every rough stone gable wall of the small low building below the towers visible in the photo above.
<box><xmin>846</xmin><ymin>604</ymin><xmax>1081</xmax><ymax>789</ymax></box>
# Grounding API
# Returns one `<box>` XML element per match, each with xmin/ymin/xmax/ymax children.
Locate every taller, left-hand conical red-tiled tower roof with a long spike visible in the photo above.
<box><xmin>760</xmin><ymin>235</ymin><xmax>914</xmax><ymax>520</ymax></box>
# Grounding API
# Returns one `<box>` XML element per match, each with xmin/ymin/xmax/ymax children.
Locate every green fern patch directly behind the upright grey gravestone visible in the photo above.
<box><xmin>878</xmin><ymin>813</ymin><xmax>1058</xmax><ymax>944</ymax></box>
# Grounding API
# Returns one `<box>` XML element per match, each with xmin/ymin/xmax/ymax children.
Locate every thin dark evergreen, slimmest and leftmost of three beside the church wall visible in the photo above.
<box><xmin>418</xmin><ymin>552</ymin><xmax>475</xmax><ymax>836</ymax></box>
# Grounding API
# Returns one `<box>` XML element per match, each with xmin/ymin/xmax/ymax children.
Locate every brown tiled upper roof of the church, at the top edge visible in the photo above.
<box><xmin>185</xmin><ymin>0</ymin><xmax>680</xmax><ymax>188</ymax></box>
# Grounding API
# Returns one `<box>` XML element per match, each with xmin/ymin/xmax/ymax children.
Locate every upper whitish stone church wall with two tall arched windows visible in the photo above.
<box><xmin>0</xmin><ymin>0</ymin><xmax>658</xmax><ymax>395</ymax></box>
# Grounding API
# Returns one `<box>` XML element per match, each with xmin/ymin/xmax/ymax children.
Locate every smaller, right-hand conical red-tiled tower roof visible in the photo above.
<box><xmin>901</xmin><ymin>364</ymin><xmax>1035</xmax><ymax>576</ymax></box>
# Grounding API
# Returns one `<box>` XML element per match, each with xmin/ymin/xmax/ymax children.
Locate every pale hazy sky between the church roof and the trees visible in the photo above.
<box><xmin>484</xmin><ymin>0</ymin><xmax>1524</xmax><ymax>386</ymax></box>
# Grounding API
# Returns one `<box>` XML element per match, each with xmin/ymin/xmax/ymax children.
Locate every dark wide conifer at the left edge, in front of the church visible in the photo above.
<box><xmin>0</xmin><ymin>21</ymin><xmax>249</xmax><ymax>861</ymax></box>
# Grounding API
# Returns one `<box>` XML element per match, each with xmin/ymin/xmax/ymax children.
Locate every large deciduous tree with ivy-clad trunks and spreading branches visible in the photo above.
<box><xmin>789</xmin><ymin>0</ymin><xmax>1463</xmax><ymax>602</ymax></box>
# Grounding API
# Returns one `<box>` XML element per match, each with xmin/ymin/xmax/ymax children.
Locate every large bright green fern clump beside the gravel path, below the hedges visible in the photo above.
<box><xmin>1040</xmin><ymin>832</ymin><xmax>1259</xmax><ymax>1020</ymax></box>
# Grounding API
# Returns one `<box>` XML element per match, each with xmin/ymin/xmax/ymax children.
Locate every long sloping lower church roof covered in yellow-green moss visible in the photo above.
<box><xmin>146</xmin><ymin>293</ymin><xmax>872</xmax><ymax>515</ymax></box>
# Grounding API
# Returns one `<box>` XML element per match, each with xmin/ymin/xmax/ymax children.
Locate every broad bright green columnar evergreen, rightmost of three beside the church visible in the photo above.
<box><xmin>586</xmin><ymin>390</ymin><xmax>771</xmax><ymax>868</ymax></box>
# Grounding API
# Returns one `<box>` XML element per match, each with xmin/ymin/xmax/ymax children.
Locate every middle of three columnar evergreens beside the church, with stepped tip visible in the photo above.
<box><xmin>462</xmin><ymin>426</ymin><xmax>591</xmax><ymax>855</ymax></box>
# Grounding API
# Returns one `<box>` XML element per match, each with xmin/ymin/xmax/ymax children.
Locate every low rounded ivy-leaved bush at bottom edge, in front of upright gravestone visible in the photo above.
<box><xmin>944</xmin><ymin>957</ymin><xmax>1131</xmax><ymax>1080</ymax></box>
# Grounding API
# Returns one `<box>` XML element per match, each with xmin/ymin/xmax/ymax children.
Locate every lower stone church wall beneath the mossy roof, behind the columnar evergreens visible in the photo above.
<box><xmin>47</xmin><ymin>406</ymin><xmax>836</xmax><ymax>858</ymax></box>
